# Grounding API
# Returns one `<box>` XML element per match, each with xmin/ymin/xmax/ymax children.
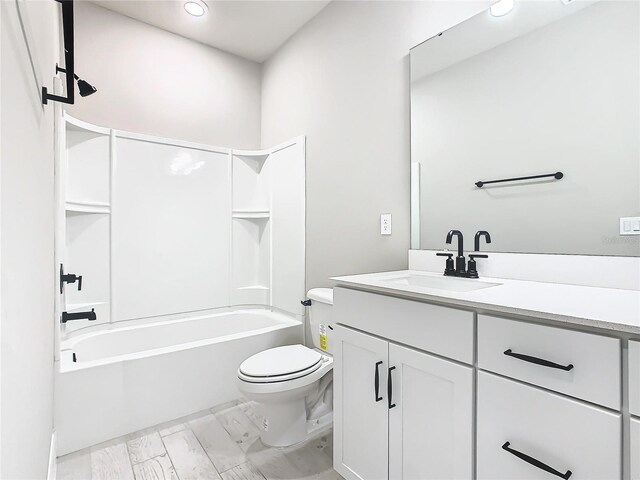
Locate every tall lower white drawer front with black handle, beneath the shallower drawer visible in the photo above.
<box><xmin>477</xmin><ymin>372</ymin><xmax>622</xmax><ymax>480</ymax></box>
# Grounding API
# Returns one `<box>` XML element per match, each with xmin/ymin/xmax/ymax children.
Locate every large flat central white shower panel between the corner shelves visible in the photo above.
<box><xmin>112</xmin><ymin>137</ymin><xmax>231</xmax><ymax>321</ymax></box>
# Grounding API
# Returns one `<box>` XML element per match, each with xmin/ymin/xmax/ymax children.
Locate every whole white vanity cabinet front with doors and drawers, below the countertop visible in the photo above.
<box><xmin>334</xmin><ymin>287</ymin><xmax>640</xmax><ymax>480</ymax></box>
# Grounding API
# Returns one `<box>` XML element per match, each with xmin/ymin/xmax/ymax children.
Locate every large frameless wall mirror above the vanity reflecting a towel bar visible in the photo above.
<box><xmin>411</xmin><ymin>0</ymin><xmax>640</xmax><ymax>256</ymax></box>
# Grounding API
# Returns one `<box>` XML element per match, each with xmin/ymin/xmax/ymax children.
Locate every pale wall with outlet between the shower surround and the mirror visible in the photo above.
<box><xmin>262</xmin><ymin>1</ymin><xmax>488</xmax><ymax>288</ymax></box>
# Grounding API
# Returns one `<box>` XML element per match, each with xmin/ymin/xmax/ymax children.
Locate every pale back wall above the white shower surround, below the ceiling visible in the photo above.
<box><xmin>67</xmin><ymin>1</ymin><xmax>260</xmax><ymax>149</ymax></box>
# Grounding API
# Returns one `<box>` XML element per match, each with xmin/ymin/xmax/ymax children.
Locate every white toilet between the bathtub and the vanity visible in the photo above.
<box><xmin>238</xmin><ymin>288</ymin><xmax>333</xmax><ymax>447</ymax></box>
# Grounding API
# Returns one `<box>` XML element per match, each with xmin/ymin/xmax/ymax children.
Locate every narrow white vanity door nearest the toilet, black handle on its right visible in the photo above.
<box><xmin>333</xmin><ymin>325</ymin><xmax>389</xmax><ymax>480</ymax></box>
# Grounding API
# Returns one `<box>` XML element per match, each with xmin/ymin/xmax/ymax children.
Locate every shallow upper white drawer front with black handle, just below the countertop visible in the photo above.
<box><xmin>478</xmin><ymin>315</ymin><xmax>622</xmax><ymax>410</ymax></box>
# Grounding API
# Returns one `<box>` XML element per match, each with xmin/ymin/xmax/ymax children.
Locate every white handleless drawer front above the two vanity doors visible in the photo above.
<box><xmin>333</xmin><ymin>288</ymin><xmax>473</xmax><ymax>364</ymax></box>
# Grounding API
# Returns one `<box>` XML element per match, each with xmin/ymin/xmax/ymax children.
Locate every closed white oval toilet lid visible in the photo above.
<box><xmin>240</xmin><ymin>345</ymin><xmax>322</xmax><ymax>378</ymax></box>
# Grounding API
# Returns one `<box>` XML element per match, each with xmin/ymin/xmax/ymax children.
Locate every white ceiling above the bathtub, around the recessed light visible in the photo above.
<box><xmin>92</xmin><ymin>0</ymin><xmax>331</xmax><ymax>62</ymax></box>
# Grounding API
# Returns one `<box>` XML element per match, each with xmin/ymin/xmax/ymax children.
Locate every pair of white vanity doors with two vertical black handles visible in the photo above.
<box><xmin>334</xmin><ymin>325</ymin><xmax>473</xmax><ymax>480</ymax></box>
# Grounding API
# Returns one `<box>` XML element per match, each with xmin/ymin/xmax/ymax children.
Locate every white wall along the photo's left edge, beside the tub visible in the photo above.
<box><xmin>0</xmin><ymin>0</ymin><xmax>60</xmax><ymax>479</ymax></box>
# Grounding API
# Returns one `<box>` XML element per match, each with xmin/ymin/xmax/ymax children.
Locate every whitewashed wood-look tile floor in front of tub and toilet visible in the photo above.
<box><xmin>57</xmin><ymin>400</ymin><xmax>342</xmax><ymax>480</ymax></box>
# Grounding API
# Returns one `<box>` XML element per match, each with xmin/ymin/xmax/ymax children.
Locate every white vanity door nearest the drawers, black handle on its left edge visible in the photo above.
<box><xmin>389</xmin><ymin>343</ymin><xmax>473</xmax><ymax>480</ymax></box>
